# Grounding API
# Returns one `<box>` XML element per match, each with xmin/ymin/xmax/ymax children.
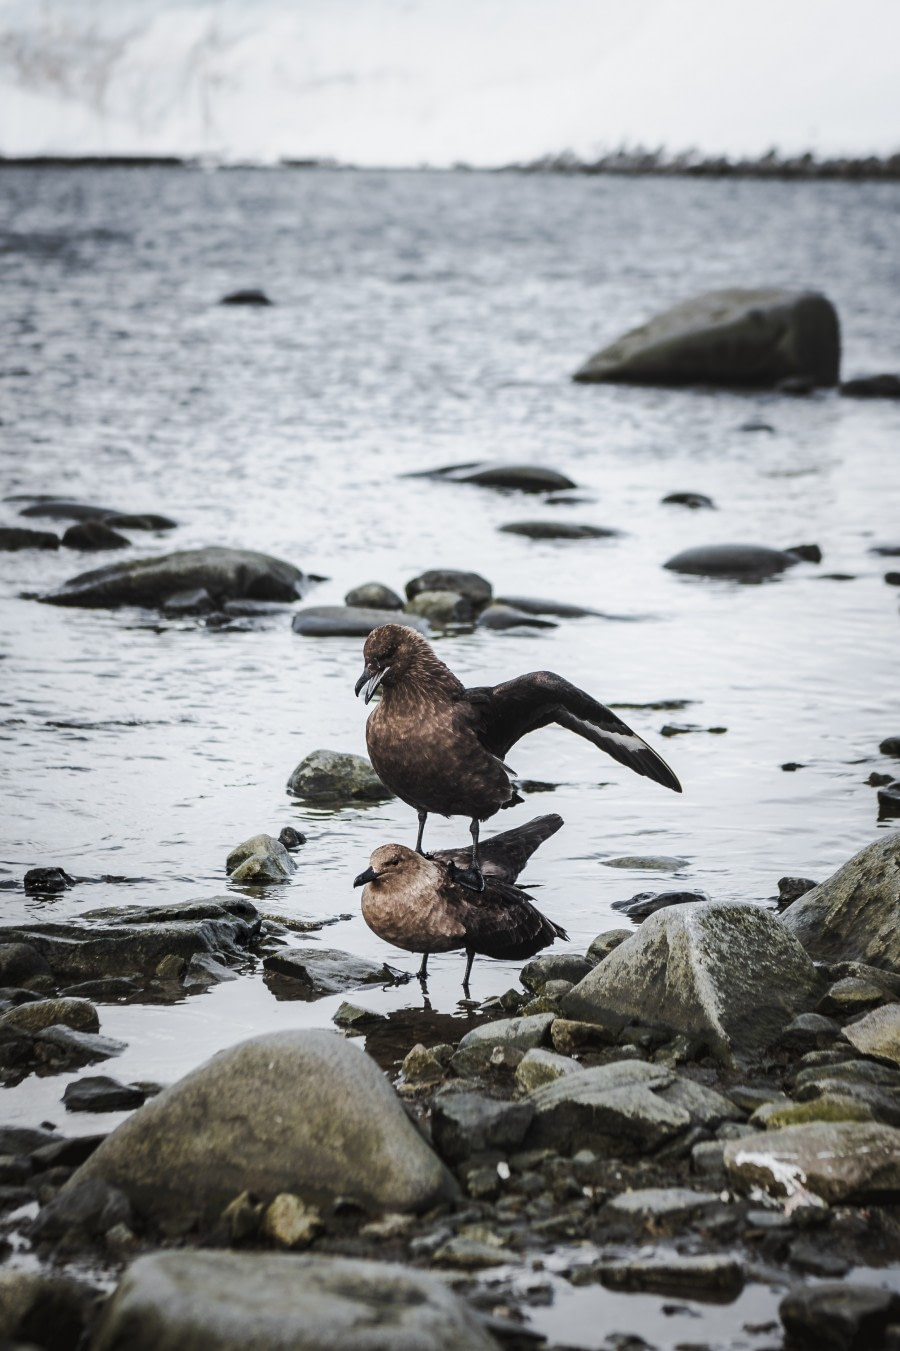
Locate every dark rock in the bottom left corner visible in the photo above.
<box><xmin>0</xmin><ymin>1271</ymin><xmax>97</xmax><ymax>1351</ymax></box>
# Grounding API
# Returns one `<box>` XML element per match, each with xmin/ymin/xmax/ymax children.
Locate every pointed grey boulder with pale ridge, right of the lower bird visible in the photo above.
<box><xmin>562</xmin><ymin>901</ymin><xmax>819</xmax><ymax>1065</ymax></box>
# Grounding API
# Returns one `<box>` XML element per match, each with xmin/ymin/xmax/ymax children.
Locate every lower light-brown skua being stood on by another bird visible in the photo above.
<box><xmin>353</xmin><ymin>816</ymin><xmax>568</xmax><ymax>989</ymax></box>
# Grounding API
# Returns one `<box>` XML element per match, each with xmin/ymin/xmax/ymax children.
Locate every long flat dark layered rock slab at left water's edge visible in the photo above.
<box><xmin>0</xmin><ymin>896</ymin><xmax>261</xmax><ymax>984</ymax></box>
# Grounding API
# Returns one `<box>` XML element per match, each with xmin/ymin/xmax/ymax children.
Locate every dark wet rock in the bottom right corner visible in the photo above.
<box><xmin>778</xmin><ymin>1281</ymin><xmax>900</xmax><ymax>1351</ymax></box>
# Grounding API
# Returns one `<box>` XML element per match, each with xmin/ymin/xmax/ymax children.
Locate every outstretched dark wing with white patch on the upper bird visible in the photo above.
<box><xmin>458</xmin><ymin>671</ymin><xmax>681</xmax><ymax>793</ymax></box>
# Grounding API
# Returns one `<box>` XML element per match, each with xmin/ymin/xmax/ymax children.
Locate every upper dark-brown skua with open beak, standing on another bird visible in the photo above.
<box><xmin>355</xmin><ymin>624</ymin><xmax>681</xmax><ymax>890</ymax></box>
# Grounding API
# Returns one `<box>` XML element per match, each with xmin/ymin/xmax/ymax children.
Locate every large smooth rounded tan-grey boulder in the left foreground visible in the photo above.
<box><xmin>66</xmin><ymin>1029</ymin><xmax>455</xmax><ymax>1232</ymax></box>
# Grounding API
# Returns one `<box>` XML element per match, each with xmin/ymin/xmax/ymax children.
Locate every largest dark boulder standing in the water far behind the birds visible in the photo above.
<box><xmin>573</xmin><ymin>286</ymin><xmax>841</xmax><ymax>385</ymax></box>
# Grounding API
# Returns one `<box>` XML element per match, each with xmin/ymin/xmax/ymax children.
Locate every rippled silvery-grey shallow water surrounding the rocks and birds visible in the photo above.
<box><xmin>0</xmin><ymin>170</ymin><xmax>900</xmax><ymax>1340</ymax></box>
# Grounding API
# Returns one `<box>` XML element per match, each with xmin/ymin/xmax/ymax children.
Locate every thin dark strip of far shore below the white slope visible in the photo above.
<box><xmin>0</xmin><ymin>146</ymin><xmax>900</xmax><ymax>182</ymax></box>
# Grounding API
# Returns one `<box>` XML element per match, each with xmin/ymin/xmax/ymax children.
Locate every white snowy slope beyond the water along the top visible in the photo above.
<box><xmin>0</xmin><ymin>0</ymin><xmax>900</xmax><ymax>165</ymax></box>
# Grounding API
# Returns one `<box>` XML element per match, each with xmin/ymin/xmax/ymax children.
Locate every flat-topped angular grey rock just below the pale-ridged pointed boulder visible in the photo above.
<box><xmin>528</xmin><ymin>1061</ymin><xmax>691</xmax><ymax>1158</ymax></box>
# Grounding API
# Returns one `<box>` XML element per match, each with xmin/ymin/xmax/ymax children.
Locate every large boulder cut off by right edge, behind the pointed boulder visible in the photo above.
<box><xmin>781</xmin><ymin>831</ymin><xmax>900</xmax><ymax>973</ymax></box>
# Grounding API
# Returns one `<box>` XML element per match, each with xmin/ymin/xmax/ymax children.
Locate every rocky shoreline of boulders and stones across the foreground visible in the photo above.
<box><xmin>0</xmin><ymin>834</ymin><xmax>900</xmax><ymax>1351</ymax></box>
